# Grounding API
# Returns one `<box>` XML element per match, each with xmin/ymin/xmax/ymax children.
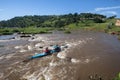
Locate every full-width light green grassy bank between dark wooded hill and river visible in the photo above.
<box><xmin>0</xmin><ymin>19</ymin><xmax>120</xmax><ymax>35</ymax></box>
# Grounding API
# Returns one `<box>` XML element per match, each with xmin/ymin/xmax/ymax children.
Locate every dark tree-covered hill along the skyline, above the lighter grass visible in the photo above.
<box><xmin>0</xmin><ymin>13</ymin><xmax>106</xmax><ymax>28</ymax></box>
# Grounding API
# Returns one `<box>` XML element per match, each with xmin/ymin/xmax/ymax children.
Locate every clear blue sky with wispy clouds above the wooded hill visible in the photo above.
<box><xmin>0</xmin><ymin>0</ymin><xmax>120</xmax><ymax>21</ymax></box>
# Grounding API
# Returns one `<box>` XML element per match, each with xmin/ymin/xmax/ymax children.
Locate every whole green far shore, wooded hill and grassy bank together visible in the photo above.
<box><xmin>0</xmin><ymin>13</ymin><xmax>120</xmax><ymax>35</ymax></box>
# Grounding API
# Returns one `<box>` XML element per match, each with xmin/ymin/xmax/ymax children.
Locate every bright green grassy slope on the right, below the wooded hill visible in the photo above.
<box><xmin>65</xmin><ymin>19</ymin><xmax>120</xmax><ymax>33</ymax></box>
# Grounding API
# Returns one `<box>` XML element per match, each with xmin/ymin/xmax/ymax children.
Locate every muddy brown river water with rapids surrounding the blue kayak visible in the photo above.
<box><xmin>0</xmin><ymin>31</ymin><xmax>120</xmax><ymax>80</ymax></box>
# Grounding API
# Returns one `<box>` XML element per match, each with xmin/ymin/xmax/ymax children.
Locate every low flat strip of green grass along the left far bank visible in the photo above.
<box><xmin>0</xmin><ymin>27</ymin><xmax>54</xmax><ymax>35</ymax></box>
